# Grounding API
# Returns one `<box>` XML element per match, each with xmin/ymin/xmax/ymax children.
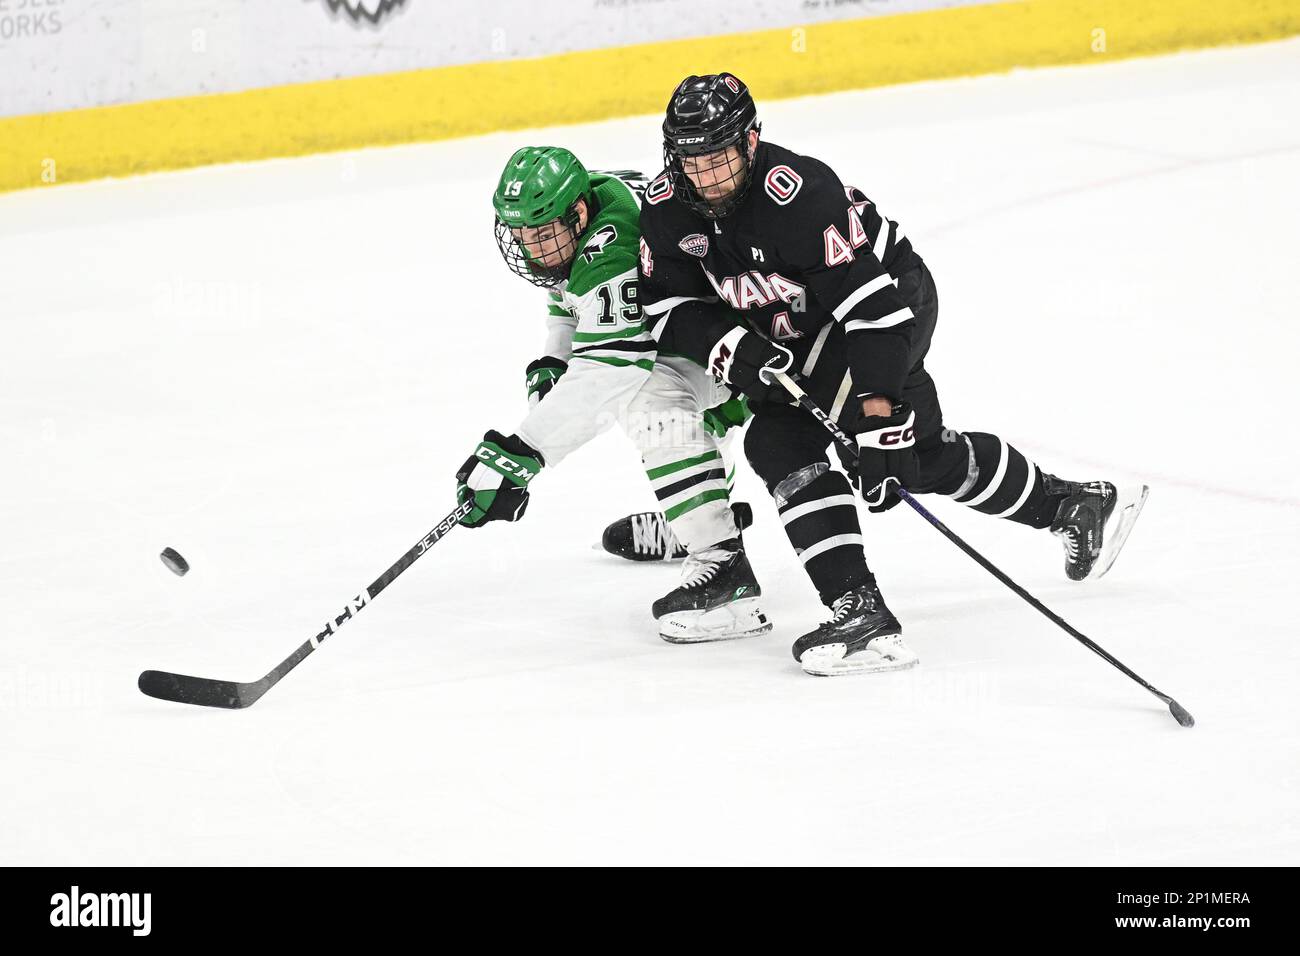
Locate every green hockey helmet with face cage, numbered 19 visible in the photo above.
<box><xmin>491</xmin><ymin>146</ymin><xmax>593</xmax><ymax>289</ymax></box>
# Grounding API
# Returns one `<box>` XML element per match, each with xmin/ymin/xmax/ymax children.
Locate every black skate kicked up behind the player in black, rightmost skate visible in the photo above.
<box><xmin>1044</xmin><ymin>475</ymin><xmax>1149</xmax><ymax>581</ymax></box>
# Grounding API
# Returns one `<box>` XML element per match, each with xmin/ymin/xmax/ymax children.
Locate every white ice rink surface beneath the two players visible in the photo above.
<box><xmin>0</xmin><ymin>42</ymin><xmax>1300</xmax><ymax>865</ymax></box>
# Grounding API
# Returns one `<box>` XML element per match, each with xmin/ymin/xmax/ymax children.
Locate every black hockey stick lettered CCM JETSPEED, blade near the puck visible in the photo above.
<box><xmin>139</xmin><ymin>499</ymin><xmax>473</xmax><ymax>710</ymax></box>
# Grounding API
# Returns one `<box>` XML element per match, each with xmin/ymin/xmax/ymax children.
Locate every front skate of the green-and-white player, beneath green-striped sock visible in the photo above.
<box><xmin>653</xmin><ymin>538</ymin><xmax>772</xmax><ymax>644</ymax></box>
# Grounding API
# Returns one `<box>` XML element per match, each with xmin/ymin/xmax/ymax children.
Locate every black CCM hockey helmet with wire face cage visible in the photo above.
<box><xmin>663</xmin><ymin>73</ymin><xmax>759</xmax><ymax>219</ymax></box>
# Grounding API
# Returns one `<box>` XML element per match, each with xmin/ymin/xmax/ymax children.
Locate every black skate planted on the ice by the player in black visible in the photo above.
<box><xmin>790</xmin><ymin>585</ymin><xmax>919</xmax><ymax>678</ymax></box>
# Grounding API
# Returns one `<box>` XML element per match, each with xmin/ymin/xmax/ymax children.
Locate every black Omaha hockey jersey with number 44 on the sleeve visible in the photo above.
<box><xmin>640</xmin><ymin>143</ymin><xmax>920</xmax><ymax>398</ymax></box>
